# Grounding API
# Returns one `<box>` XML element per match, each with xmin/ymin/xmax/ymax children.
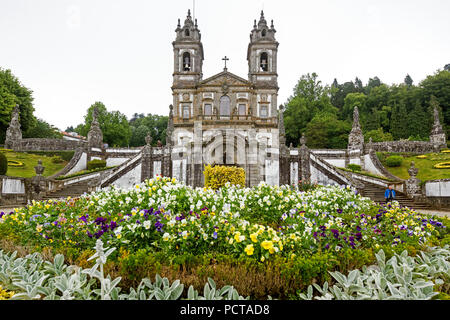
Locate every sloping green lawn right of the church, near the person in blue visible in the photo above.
<box><xmin>377</xmin><ymin>152</ymin><xmax>450</xmax><ymax>181</ymax></box>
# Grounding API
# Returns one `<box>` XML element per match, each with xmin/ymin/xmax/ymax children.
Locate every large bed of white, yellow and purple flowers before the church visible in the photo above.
<box><xmin>0</xmin><ymin>177</ymin><xmax>448</xmax><ymax>297</ymax></box>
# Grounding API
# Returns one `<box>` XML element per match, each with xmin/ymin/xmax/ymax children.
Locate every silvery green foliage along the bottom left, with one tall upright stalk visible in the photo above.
<box><xmin>0</xmin><ymin>240</ymin><xmax>249</xmax><ymax>300</ymax></box>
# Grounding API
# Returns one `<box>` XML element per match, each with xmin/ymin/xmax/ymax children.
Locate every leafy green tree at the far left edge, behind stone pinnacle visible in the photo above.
<box><xmin>0</xmin><ymin>68</ymin><xmax>36</xmax><ymax>143</ymax></box>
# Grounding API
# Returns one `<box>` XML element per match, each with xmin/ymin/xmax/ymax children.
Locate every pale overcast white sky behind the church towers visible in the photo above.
<box><xmin>0</xmin><ymin>0</ymin><xmax>450</xmax><ymax>130</ymax></box>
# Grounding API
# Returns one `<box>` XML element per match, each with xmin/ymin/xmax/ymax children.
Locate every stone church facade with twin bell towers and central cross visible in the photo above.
<box><xmin>167</xmin><ymin>11</ymin><xmax>285</xmax><ymax>186</ymax></box>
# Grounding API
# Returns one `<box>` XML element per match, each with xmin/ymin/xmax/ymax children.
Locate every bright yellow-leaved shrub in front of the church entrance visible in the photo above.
<box><xmin>203</xmin><ymin>165</ymin><xmax>245</xmax><ymax>190</ymax></box>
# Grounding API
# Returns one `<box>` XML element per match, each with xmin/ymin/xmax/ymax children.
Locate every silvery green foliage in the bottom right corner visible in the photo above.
<box><xmin>299</xmin><ymin>245</ymin><xmax>450</xmax><ymax>300</ymax></box>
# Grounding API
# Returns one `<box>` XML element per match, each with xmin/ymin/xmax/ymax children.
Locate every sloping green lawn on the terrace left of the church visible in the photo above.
<box><xmin>2</xmin><ymin>151</ymin><xmax>67</xmax><ymax>178</ymax></box>
